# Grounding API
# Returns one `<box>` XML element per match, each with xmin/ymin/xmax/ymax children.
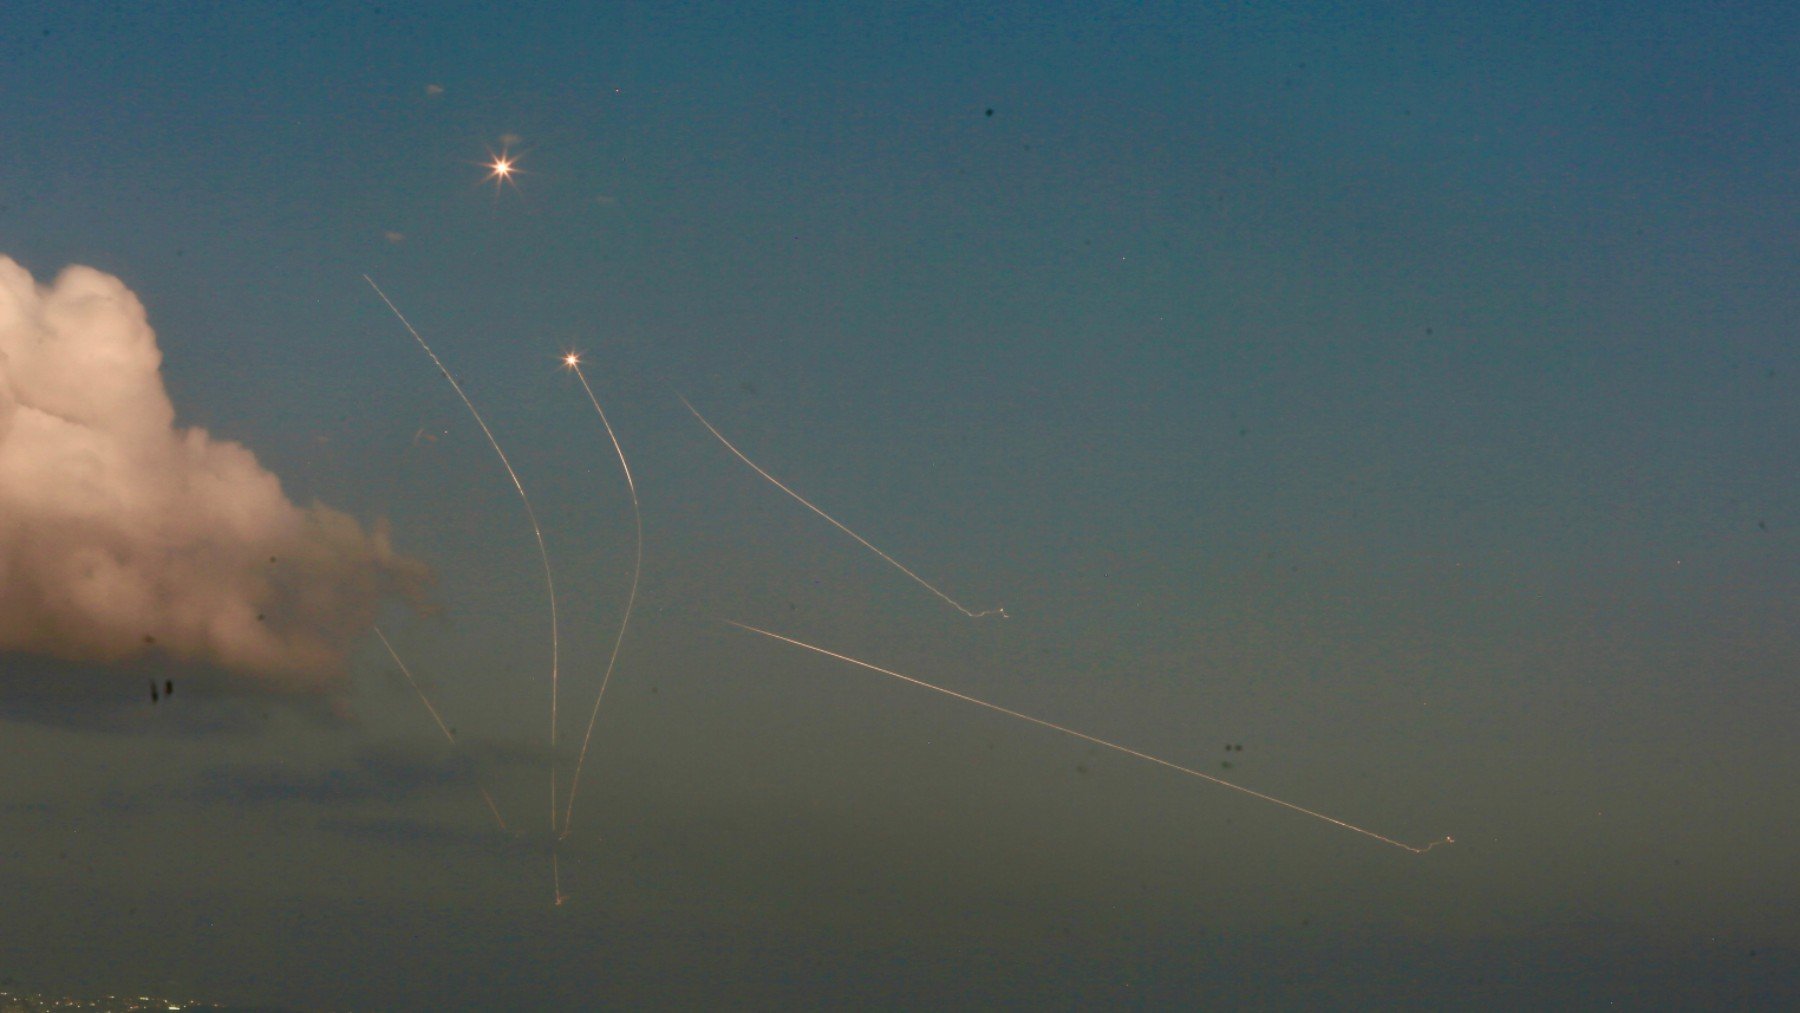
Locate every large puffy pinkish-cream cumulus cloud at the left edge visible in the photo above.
<box><xmin>0</xmin><ymin>255</ymin><xmax>428</xmax><ymax>689</ymax></box>
